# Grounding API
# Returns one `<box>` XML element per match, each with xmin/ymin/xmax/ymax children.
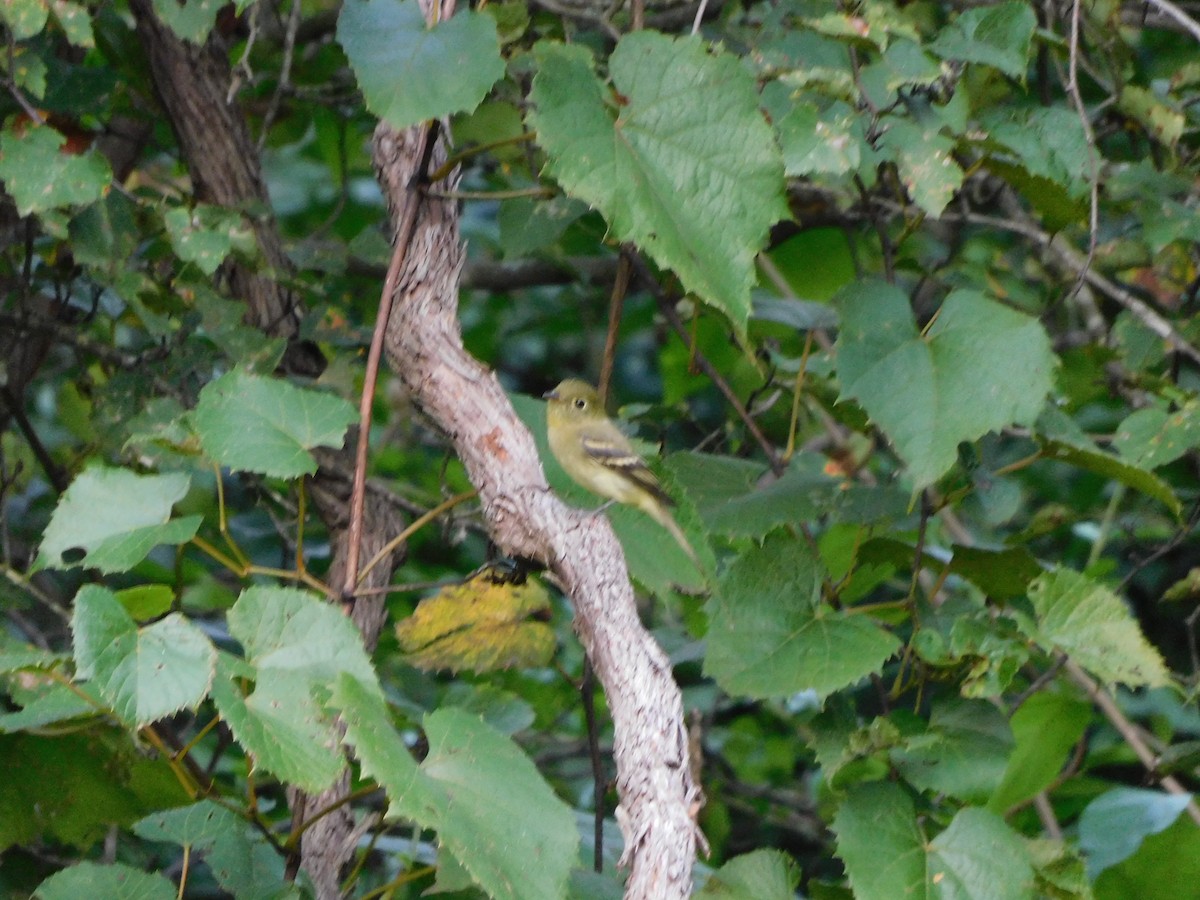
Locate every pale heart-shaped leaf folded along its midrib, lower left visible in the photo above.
<box><xmin>71</xmin><ymin>584</ymin><xmax>216</xmax><ymax>727</ymax></box>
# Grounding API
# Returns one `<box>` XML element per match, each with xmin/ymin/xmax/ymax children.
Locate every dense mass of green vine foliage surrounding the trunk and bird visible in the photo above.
<box><xmin>0</xmin><ymin>0</ymin><xmax>1200</xmax><ymax>900</ymax></box>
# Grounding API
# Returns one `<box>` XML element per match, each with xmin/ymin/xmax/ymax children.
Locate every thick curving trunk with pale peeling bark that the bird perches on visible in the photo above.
<box><xmin>374</xmin><ymin>118</ymin><xmax>701</xmax><ymax>900</ymax></box>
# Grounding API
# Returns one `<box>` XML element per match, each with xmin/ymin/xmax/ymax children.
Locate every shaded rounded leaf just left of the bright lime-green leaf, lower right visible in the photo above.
<box><xmin>892</xmin><ymin>698</ymin><xmax>1013</xmax><ymax>802</ymax></box>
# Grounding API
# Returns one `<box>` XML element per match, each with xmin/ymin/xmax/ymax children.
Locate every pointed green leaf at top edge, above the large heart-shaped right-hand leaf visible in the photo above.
<box><xmin>929</xmin><ymin>0</ymin><xmax>1038</xmax><ymax>80</ymax></box>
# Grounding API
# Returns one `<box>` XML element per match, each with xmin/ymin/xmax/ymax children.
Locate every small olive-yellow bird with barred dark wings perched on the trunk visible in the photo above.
<box><xmin>542</xmin><ymin>378</ymin><xmax>698</xmax><ymax>565</ymax></box>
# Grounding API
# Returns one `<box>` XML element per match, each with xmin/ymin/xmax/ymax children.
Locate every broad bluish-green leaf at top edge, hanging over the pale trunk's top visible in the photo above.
<box><xmin>337</xmin><ymin>0</ymin><xmax>504</xmax><ymax>128</ymax></box>
